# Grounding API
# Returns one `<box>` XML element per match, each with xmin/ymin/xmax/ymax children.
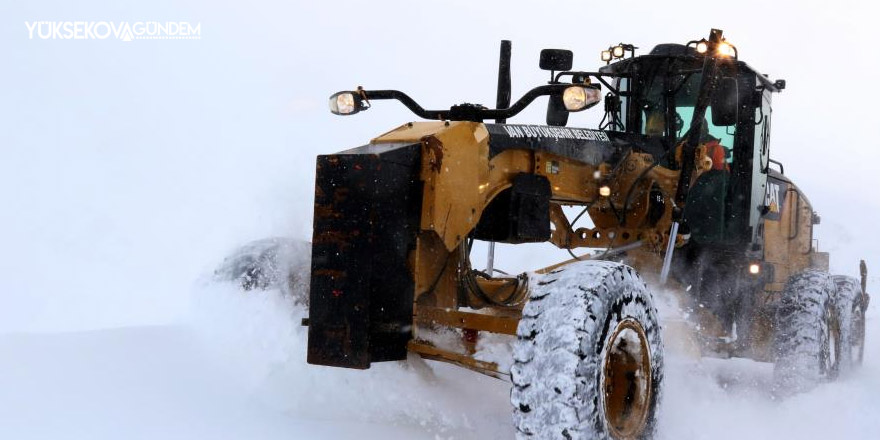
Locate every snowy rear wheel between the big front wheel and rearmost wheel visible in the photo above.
<box><xmin>774</xmin><ymin>270</ymin><xmax>842</xmax><ymax>394</ymax></box>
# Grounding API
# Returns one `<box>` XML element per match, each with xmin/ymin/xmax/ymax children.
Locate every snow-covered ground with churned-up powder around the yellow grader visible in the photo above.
<box><xmin>0</xmin><ymin>286</ymin><xmax>880</xmax><ymax>440</ymax></box>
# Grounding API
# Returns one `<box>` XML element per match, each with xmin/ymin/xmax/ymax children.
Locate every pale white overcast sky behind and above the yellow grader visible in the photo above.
<box><xmin>0</xmin><ymin>0</ymin><xmax>880</xmax><ymax>331</ymax></box>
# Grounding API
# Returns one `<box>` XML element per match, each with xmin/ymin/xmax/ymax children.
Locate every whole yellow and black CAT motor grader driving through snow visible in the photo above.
<box><xmin>305</xmin><ymin>29</ymin><xmax>868</xmax><ymax>439</ymax></box>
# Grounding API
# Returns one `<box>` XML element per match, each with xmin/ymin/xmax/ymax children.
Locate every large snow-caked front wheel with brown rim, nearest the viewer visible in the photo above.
<box><xmin>511</xmin><ymin>261</ymin><xmax>663</xmax><ymax>439</ymax></box>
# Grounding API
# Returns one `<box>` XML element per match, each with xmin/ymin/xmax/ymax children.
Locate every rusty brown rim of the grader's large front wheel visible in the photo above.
<box><xmin>602</xmin><ymin>318</ymin><xmax>652</xmax><ymax>439</ymax></box>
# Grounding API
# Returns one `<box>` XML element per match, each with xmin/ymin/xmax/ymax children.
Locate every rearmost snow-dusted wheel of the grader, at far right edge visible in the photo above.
<box><xmin>834</xmin><ymin>275</ymin><xmax>865</xmax><ymax>373</ymax></box>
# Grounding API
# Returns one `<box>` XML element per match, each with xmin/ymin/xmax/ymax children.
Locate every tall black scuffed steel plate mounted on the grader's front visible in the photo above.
<box><xmin>308</xmin><ymin>144</ymin><xmax>421</xmax><ymax>369</ymax></box>
